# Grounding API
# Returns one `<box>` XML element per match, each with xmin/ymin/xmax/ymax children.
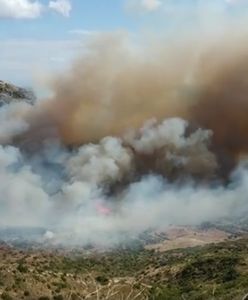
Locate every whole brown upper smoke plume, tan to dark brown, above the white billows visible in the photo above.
<box><xmin>14</xmin><ymin>22</ymin><xmax>248</xmax><ymax>178</ymax></box>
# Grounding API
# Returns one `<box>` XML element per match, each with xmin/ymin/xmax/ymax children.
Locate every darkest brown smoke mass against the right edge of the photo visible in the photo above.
<box><xmin>191</xmin><ymin>49</ymin><xmax>248</xmax><ymax>155</ymax></box>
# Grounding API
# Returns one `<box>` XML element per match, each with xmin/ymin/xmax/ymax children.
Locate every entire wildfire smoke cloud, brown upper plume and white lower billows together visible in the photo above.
<box><xmin>0</xmin><ymin>4</ymin><xmax>248</xmax><ymax>245</ymax></box>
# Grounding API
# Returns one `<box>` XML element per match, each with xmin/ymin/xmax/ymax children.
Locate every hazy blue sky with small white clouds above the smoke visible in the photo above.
<box><xmin>0</xmin><ymin>0</ymin><xmax>247</xmax><ymax>85</ymax></box>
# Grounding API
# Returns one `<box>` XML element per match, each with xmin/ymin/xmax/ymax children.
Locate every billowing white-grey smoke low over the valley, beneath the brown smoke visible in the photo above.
<box><xmin>0</xmin><ymin>98</ymin><xmax>248</xmax><ymax>246</ymax></box>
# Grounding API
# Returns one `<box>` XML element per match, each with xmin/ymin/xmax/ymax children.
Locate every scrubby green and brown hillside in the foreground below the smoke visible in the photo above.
<box><xmin>0</xmin><ymin>229</ymin><xmax>248</xmax><ymax>300</ymax></box>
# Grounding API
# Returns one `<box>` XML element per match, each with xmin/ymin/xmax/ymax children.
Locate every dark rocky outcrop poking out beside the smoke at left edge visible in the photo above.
<box><xmin>0</xmin><ymin>80</ymin><xmax>35</xmax><ymax>106</ymax></box>
